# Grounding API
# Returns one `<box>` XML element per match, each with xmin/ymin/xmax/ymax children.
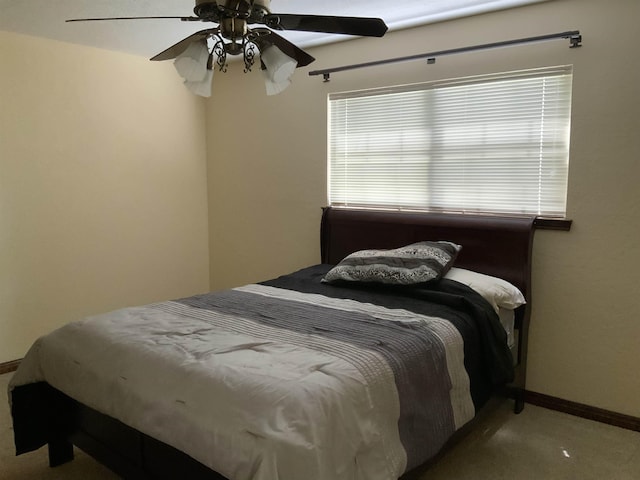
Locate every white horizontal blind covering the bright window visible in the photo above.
<box><xmin>328</xmin><ymin>66</ymin><xmax>572</xmax><ymax>217</ymax></box>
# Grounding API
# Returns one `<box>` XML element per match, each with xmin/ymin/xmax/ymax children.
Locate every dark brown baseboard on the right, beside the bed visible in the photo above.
<box><xmin>524</xmin><ymin>390</ymin><xmax>640</xmax><ymax>432</ymax></box>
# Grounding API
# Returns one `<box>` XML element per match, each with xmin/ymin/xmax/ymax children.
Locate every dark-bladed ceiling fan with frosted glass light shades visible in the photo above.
<box><xmin>67</xmin><ymin>0</ymin><xmax>387</xmax><ymax>96</ymax></box>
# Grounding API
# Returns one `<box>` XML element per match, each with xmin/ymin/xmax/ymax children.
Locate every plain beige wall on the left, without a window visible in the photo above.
<box><xmin>0</xmin><ymin>32</ymin><xmax>209</xmax><ymax>363</ymax></box>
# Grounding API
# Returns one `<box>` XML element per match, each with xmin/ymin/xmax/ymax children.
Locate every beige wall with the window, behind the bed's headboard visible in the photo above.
<box><xmin>207</xmin><ymin>0</ymin><xmax>640</xmax><ymax>416</ymax></box>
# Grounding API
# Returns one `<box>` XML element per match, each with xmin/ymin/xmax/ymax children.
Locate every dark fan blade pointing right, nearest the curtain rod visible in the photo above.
<box><xmin>264</xmin><ymin>13</ymin><xmax>387</xmax><ymax>37</ymax></box>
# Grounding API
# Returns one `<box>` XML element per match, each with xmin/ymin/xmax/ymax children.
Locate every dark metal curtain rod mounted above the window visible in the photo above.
<box><xmin>309</xmin><ymin>30</ymin><xmax>582</xmax><ymax>82</ymax></box>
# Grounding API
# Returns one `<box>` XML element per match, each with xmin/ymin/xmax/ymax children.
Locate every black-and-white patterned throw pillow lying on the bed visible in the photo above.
<box><xmin>322</xmin><ymin>242</ymin><xmax>462</xmax><ymax>285</ymax></box>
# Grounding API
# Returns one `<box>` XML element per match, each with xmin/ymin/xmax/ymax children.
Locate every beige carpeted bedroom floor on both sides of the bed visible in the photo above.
<box><xmin>0</xmin><ymin>374</ymin><xmax>640</xmax><ymax>480</ymax></box>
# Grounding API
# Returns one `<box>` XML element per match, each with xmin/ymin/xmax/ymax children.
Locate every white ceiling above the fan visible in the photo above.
<box><xmin>0</xmin><ymin>0</ymin><xmax>545</xmax><ymax>57</ymax></box>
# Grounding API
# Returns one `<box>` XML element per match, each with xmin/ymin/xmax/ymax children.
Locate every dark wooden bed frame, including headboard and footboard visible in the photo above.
<box><xmin>35</xmin><ymin>207</ymin><xmax>534</xmax><ymax>480</ymax></box>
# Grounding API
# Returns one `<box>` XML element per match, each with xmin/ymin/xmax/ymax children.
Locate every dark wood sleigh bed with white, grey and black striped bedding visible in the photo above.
<box><xmin>10</xmin><ymin>208</ymin><xmax>534</xmax><ymax>480</ymax></box>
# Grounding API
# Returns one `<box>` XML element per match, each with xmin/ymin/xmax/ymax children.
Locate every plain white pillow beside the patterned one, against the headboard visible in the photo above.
<box><xmin>444</xmin><ymin>267</ymin><xmax>527</xmax><ymax>312</ymax></box>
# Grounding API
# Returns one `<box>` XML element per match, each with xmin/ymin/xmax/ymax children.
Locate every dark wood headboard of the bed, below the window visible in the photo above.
<box><xmin>321</xmin><ymin>207</ymin><xmax>535</xmax><ymax>299</ymax></box>
